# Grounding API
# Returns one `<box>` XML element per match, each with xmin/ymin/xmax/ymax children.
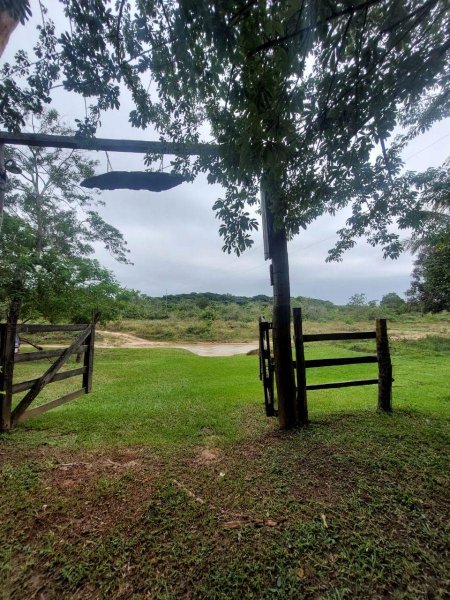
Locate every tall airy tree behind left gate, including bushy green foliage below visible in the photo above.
<box><xmin>0</xmin><ymin>111</ymin><xmax>128</xmax><ymax>321</ymax></box>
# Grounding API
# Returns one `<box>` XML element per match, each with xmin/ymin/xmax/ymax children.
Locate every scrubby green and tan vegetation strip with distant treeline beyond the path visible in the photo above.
<box><xmin>101</xmin><ymin>292</ymin><xmax>450</xmax><ymax>342</ymax></box>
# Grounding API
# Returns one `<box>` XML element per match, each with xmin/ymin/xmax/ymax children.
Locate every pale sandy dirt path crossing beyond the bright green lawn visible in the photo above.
<box><xmin>96</xmin><ymin>330</ymin><xmax>258</xmax><ymax>356</ymax></box>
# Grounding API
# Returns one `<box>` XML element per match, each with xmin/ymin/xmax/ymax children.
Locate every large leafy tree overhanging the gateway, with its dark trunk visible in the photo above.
<box><xmin>0</xmin><ymin>0</ymin><xmax>450</xmax><ymax>427</ymax></box>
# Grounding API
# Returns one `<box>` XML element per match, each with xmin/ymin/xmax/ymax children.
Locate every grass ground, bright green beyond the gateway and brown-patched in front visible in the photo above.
<box><xmin>0</xmin><ymin>337</ymin><xmax>450</xmax><ymax>600</ymax></box>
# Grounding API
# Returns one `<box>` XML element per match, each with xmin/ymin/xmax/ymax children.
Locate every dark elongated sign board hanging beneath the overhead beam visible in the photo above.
<box><xmin>81</xmin><ymin>171</ymin><xmax>186</xmax><ymax>192</ymax></box>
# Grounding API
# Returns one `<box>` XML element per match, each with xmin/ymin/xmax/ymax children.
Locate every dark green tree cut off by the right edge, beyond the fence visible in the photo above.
<box><xmin>407</xmin><ymin>228</ymin><xmax>450</xmax><ymax>313</ymax></box>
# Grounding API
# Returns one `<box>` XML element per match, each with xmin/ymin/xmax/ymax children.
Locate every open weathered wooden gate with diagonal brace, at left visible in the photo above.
<box><xmin>0</xmin><ymin>319</ymin><xmax>95</xmax><ymax>432</ymax></box>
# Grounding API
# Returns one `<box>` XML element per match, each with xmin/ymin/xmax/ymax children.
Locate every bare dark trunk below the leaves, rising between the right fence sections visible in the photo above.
<box><xmin>271</xmin><ymin>229</ymin><xmax>298</xmax><ymax>429</ymax></box>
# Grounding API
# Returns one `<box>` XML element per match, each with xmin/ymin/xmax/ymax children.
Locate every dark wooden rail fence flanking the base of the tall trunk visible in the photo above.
<box><xmin>259</xmin><ymin>308</ymin><xmax>393</xmax><ymax>423</ymax></box>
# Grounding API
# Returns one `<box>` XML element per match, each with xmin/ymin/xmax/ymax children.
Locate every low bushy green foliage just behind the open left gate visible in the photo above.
<box><xmin>0</xmin><ymin>214</ymin><xmax>122</xmax><ymax>323</ymax></box>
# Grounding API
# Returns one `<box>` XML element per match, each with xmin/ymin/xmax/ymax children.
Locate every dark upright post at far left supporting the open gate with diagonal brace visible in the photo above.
<box><xmin>0</xmin><ymin>300</ymin><xmax>20</xmax><ymax>432</ymax></box>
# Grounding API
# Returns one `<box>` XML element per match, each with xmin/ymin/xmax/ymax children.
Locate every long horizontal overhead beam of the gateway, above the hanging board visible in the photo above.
<box><xmin>0</xmin><ymin>131</ymin><xmax>220</xmax><ymax>156</ymax></box>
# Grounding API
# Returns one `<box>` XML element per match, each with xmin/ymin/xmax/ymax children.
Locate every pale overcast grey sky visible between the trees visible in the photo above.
<box><xmin>0</xmin><ymin>0</ymin><xmax>450</xmax><ymax>304</ymax></box>
